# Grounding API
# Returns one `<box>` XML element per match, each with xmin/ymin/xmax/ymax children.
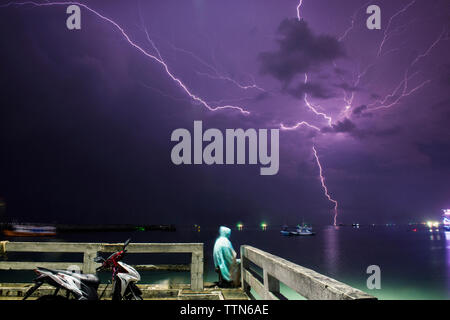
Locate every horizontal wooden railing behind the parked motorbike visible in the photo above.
<box><xmin>0</xmin><ymin>241</ymin><xmax>203</xmax><ymax>291</ymax></box>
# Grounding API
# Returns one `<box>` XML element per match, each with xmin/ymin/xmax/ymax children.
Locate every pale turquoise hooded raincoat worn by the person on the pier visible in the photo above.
<box><xmin>213</xmin><ymin>226</ymin><xmax>236</xmax><ymax>281</ymax></box>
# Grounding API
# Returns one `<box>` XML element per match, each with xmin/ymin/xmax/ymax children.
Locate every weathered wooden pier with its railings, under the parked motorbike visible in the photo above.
<box><xmin>0</xmin><ymin>241</ymin><xmax>375</xmax><ymax>300</ymax></box>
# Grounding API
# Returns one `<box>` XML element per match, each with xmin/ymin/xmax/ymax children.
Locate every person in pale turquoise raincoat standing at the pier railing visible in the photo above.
<box><xmin>213</xmin><ymin>226</ymin><xmax>240</xmax><ymax>287</ymax></box>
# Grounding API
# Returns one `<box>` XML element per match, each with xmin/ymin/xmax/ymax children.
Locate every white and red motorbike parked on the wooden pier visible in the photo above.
<box><xmin>23</xmin><ymin>239</ymin><xmax>142</xmax><ymax>301</ymax></box>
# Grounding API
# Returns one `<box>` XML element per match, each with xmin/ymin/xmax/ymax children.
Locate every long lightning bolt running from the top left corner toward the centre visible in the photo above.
<box><xmin>0</xmin><ymin>1</ymin><xmax>250</xmax><ymax>115</ymax></box>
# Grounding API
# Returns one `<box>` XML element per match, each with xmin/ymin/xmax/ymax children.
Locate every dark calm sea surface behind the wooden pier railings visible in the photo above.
<box><xmin>0</xmin><ymin>226</ymin><xmax>450</xmax><ymax>299</ymax></box>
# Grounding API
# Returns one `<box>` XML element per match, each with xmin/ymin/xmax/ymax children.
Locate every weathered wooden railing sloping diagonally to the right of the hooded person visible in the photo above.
<box><xmin>241</xmin><ymin>246</ymin><xmax>376</xmax><ymax>300</ymax></box>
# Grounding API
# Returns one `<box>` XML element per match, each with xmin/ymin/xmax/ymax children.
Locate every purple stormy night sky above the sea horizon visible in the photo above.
<box><xmin>0</xmin><ymin>0</ymin><xmax>450</xmax><ymax>226</ymax></box>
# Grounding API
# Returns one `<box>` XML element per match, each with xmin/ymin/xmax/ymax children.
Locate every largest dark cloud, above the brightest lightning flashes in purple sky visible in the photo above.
<box><xmin>259</xmin><ymin>19</ymin><xmax>344</xmax><ymax>87</ymax></box>
